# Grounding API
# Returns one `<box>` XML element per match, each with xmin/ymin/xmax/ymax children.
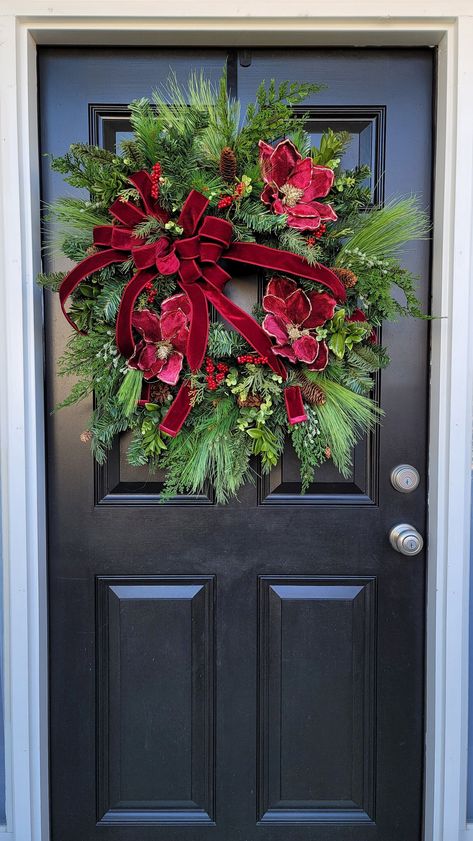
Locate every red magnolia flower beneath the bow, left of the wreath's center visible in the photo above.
<box><xmin>128</xmin><ymin>295</ymin><xmax>190</xmax><ymax>385</ymax></box>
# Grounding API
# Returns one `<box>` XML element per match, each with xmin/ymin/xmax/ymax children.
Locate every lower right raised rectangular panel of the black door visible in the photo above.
<box><xmin>259</xmin><ymin>576</ymin><xmax>376</xmax><ymax>824</ymax></box>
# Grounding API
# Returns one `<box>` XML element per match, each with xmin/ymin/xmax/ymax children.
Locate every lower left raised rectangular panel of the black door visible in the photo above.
<box><xmin>96</xmin><ymin>576</ymin><xmax>215</xmax><ymax>825</ymax></box>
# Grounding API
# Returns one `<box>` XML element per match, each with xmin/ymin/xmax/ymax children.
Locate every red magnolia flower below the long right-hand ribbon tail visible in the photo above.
<box><xmin>263</xmin><ymin>277</ymin><xmax>336</xmax><ymax>371</ymax></box>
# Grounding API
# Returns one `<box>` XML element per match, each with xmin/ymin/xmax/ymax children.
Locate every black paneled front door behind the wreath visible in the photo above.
<box><xmin>39</xmin><ymin>48</ymin><xmax>433</xmax><ymax>841</ymax></box>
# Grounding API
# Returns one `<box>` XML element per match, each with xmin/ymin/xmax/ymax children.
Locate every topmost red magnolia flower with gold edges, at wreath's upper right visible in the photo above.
<box><xmin>259</xmin><ymin>140</ymin><xmax>337</xmax><ymax>231</ymax></box>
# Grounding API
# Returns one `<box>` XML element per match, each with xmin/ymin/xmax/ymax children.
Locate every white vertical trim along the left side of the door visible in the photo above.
<box><xmin>0</xmin><ymin>18</ymin><xmax>48</xmax><ymax>841</ymax></box>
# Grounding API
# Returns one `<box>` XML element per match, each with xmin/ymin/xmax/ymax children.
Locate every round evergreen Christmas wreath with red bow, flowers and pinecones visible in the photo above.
<box><xmin>39</xmin><ymin>75</ymin><xmax>428</xmax><ymax>502</ymax></box>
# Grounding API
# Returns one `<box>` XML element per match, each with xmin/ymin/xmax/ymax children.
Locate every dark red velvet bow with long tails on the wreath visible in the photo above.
<box><xmin>59</xmin><ymin>172</ymin><xmax>346</xmax><ymax>436</ymax></box>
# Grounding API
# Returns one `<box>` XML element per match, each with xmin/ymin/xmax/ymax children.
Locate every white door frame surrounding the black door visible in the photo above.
<box><xmin>0</xmin><ymin>6</ymin><xmax>473</xmax><ymax>841</ymax></box>
